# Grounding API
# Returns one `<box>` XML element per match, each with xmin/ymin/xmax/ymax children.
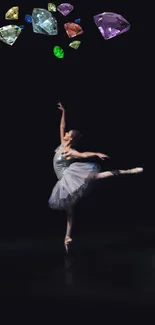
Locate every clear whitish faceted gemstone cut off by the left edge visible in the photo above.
<box><xmin>0</xmin><ymin>25</ymin><xmax>21</xmax><ymax>45</ymax></box>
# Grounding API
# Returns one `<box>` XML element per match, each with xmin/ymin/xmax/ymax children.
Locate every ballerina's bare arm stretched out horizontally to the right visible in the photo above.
<box><xmin>64</xmin><ymin>149</ymin><xmax>109</xmax><ymax>160</ymax></box>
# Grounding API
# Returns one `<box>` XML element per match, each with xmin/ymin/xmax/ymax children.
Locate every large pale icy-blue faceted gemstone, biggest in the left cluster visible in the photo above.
<box><xmin>32</xmin><ymin>8</ymin><xmax>58</xmax><ymax>35</ymax></box>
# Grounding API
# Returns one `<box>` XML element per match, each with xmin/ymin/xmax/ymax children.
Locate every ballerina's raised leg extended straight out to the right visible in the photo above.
<box><xmin>96</xmin><ymin>167</ymin><xmax>143</xmax><ymax>179</ymax></box>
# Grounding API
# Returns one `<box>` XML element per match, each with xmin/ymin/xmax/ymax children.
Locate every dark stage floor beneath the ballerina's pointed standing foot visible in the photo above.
<box><xmin>0</xmin><ymin>227</ymin><xmax>155</xmax><ymax>324</ymax></box>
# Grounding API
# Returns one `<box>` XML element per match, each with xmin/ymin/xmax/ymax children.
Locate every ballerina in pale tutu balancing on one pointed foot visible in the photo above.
<box><xmin>48</xmin><ymin>102</ymin><xmax>143</xmax><ymax>252</ymax></box>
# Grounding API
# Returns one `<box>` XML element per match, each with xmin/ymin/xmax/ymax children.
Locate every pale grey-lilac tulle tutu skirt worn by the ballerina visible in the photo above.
<box><xmin>48</xmin><ymin>162</ymin><xmax>100</xmax><ymax>210</ymax></box>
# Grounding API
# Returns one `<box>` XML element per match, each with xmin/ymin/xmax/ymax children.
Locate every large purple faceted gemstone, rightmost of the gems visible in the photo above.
<box><xmin>94</xmin><ymin>12</ymin><xmax>130</xmax><ymax>40</ymax></box>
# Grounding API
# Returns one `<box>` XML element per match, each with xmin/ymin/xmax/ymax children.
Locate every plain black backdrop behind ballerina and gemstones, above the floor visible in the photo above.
<box><xmin>0</xmin><ymin>1</ymin><xmax>145</xmax><ymax>239</ymax></box>
